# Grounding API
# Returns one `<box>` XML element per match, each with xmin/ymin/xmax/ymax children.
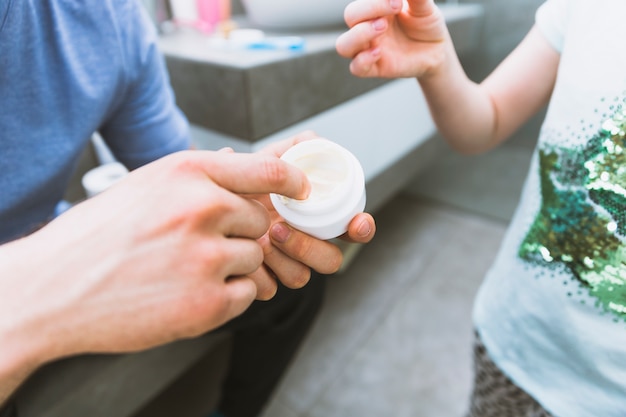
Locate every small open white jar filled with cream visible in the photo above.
<box><xmin>270</xmin><ymin>139</ymin><xmax>365</xmax><ymax>240</ymax></box>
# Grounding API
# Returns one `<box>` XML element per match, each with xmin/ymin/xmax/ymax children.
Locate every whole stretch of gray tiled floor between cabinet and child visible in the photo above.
<box><xmin>264</xmin><ymin>197</ymin><xmax>505</xmax><ymax>417</ymax></box>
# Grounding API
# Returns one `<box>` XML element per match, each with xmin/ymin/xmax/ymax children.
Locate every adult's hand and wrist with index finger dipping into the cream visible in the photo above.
<box><xmin>0</xmin><ymin>151</ymin><xmax>310</xmax><ymax>370</ymax></box>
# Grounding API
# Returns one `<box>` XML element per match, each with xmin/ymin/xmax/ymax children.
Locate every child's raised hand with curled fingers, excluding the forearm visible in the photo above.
<box><xmin>336</xmin><ymin>0</ymin><xmax>451</xmax><ymax>78</ymax></box>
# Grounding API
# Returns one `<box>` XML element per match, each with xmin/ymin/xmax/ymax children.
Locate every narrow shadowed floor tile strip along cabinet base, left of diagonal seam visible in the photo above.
<box><xmin>260</xmin><ymin>198</ymin><xmax>482</xmax><ymax>417</ymax></box>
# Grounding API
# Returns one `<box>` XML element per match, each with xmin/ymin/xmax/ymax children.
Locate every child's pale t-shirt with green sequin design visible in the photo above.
<box><xmin>474</xmin><ymin>0</ymin><xmax>626</xmax><ymax>417</ymax></box>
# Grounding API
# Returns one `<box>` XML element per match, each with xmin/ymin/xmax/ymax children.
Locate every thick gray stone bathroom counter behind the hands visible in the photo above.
<box><xmin>159</xmin><ymin>4</ymin><xmax>483</xmax><ymax>142</ymax></box>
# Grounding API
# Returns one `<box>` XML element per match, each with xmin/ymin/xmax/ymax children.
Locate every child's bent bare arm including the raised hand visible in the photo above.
<box><xmin>337</xmin><ymin>0</ymin><xmax>559</xmax><ymax>153</ymax></box>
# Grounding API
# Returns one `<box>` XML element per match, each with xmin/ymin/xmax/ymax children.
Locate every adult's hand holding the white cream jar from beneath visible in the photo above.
<box><xmin>241</xmin><ymin>131</ymin><xmax>376</xmax><ymax>300</ymax></box>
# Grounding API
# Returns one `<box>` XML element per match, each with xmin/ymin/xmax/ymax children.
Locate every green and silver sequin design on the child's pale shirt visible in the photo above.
<box><xmin>518</xmin><ymin>108</ymin><xmax>626</xmax><ymax>321</ymax></box>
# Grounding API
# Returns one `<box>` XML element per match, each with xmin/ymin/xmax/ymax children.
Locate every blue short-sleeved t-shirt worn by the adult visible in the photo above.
<box><xmin>0</xmin><ymin>0</ymin><xmax>189</xmax><ymax>242</ymax></box>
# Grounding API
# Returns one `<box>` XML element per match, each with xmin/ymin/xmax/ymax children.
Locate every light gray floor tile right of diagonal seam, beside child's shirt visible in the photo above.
<box><xmin>307</xmin><ymin>202</ymin><xmax>504</xmax><ymax>417</ymax></box>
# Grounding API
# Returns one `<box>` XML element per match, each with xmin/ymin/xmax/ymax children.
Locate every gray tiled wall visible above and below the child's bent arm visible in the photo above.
<box><xmin>405</xmin><ymin>0</ymin><xmax>545</xmax><ymax>222</ymax></box>
